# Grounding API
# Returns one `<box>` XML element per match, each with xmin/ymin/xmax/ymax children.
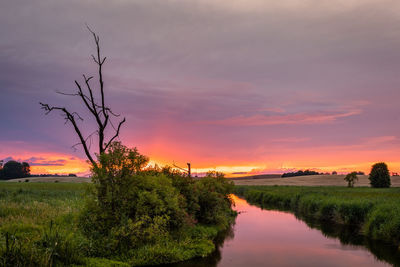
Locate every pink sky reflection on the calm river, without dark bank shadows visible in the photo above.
<box><xmin>206</xmin><ymin>197</ymin><xmax>389</xmax><ymax>267</ymax></box>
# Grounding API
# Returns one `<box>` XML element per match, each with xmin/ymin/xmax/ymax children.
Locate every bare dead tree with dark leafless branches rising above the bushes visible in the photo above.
<box><xmin>40</xmin><ymin>27</ymin><xmax>126</xmax><ymax>168</ymax></box>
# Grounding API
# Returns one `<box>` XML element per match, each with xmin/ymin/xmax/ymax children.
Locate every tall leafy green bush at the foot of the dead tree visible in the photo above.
<box><xmin>81</xmin><ymin>142</ymin><xmax>184</xmax><ymax>256</ymax></box>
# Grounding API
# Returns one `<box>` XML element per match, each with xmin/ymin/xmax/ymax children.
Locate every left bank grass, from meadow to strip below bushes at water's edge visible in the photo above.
<box><xmin>0</xmin><ymin>182</ymin><xmax>234</xmax><ymax>266</ymax></box>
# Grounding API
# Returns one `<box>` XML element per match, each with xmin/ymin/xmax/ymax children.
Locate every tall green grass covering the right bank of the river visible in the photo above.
<box><xmin>235</xmin><ymin>186</ymin><xmax>400</xmax><ymax>246</ymax></box>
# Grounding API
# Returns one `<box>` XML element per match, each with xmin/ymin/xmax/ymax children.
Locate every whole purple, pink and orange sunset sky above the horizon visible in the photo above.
<box><xmin>0</xmin><ymin>0</ymin><xmax>400</xmax><ymax>175</ymax></box>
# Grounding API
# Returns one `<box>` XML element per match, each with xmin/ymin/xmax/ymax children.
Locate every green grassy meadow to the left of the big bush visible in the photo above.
<box><xmin>0</xmin><ymin>183</ymin><xmax>87</xmax><ymax>266</ymax></box>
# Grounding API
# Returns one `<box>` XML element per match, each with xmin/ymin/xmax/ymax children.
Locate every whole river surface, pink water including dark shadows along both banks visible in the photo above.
<box><xmin>169</xmin><ymin>196</ymin><xmax>400</xmax><ymax>267</ymax></box>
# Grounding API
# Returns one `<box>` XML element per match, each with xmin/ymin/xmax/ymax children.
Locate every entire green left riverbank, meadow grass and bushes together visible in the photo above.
<box><xmin>0</xmin><ymin>147</ymin><xmax>236</xmax><ymax>266</ymax></box>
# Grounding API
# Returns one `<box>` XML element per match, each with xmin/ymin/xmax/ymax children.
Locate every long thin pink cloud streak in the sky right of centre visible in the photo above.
<box><xmin>203</xmin><ymin>110</ymin><xmax>362</xmax><ymax>126</ymax></box>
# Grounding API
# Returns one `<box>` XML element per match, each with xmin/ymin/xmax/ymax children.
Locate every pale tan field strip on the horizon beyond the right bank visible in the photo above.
<box><xmin>233</xmin><ymin>175</ymin><xmax>400</xmax><ymax>187</ymax></box>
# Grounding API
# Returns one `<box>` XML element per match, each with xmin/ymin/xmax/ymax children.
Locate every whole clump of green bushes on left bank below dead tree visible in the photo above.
<box><xmin>80</xmin><ymin>142</ymin><xmax>233</xmax><ymax>264</ymax></box>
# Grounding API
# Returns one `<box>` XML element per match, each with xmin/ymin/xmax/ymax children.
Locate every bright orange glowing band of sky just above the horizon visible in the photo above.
<box><xmin>0</xmin><ymin>144</ymin><xmax>400</xmax><ymax>177</ymax></box>
